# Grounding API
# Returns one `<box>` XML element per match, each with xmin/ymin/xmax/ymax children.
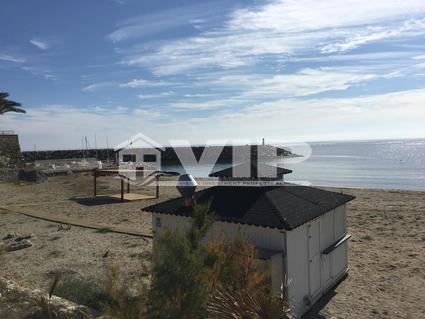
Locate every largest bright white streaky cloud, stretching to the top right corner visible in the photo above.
<box><xmin>117</xmin><ymin>0</ymin><xmax>425</xmax><ymax>75</ymax></box>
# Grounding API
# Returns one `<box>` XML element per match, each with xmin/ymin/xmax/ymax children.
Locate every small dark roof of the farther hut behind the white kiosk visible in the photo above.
<box><xmin>209</xmin><ymin>162</ymin><xmax>292</xmax><ymax>178</ymax></box>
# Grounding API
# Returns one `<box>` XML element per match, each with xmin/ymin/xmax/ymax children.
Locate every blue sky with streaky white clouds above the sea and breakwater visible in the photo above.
<box><xmin>0</xmin><ymin>0</ymin><xmax>425</xmax><ymax>150</ymax></box>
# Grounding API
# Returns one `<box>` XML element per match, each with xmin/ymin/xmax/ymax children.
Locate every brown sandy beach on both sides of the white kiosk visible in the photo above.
<box><xmin>0</xmin><ymin>174</ymin><xmax>425</xmax><ymax>318</ymax></box>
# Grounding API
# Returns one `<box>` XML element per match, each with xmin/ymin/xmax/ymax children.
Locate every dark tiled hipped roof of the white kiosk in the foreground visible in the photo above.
<box><xmin>143</xmin><ymin>185</ymin><xmax>354</xmax><ymax>230</ymax></box>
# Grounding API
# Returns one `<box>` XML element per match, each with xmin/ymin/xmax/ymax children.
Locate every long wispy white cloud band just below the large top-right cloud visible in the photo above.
<box><xmin>162</xmin><ymin>67</ymin><xmax>378</xmax><ymax>110</ymax></box>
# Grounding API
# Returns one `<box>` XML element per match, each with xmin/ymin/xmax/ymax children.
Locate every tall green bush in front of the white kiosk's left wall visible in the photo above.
<box><xmin>149</xmin><ymin>205</ymin><xmax>214</xmax><ymax>319</ymax></box>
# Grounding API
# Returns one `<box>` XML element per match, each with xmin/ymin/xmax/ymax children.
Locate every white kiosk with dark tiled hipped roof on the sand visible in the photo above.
<box><xmin>144</xmin><ymin>166</ymin><xmax>354</xmax><ymax>317</ymax></box>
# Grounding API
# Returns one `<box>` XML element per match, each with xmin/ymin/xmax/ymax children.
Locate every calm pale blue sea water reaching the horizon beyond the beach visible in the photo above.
<box><xmin>163</xmin><ymin>139</ymin><xmax>425</xmax><ymax>190</ymax></box>
